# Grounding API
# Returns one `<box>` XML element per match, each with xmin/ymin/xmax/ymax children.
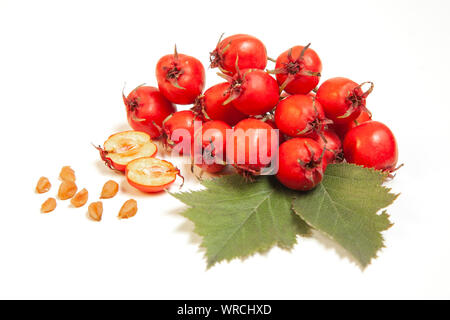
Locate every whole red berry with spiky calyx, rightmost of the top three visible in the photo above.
<box><xmin>273</xmin><ymin>45</ymin><xmax>322</xmax><ymax>94</ymax></box>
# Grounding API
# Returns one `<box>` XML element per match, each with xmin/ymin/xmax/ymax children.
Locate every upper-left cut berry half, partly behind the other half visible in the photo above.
<box><xmin>96</xmin><ymin>131</ymin><xmax>158</xmax><ymax>171</ymax></box>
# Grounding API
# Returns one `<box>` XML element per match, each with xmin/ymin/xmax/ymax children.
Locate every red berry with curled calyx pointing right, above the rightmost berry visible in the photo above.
<box><xmin>317</xmin><ymin>78</ymin><xmax>373</xmax><ymax>124</ymax></box>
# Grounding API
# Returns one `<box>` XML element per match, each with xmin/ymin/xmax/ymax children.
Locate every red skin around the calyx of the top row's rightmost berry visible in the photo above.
<box><xmin>275</xmin><ymin>46</ymin><xmax>322</xmax><ymax>94</ymax></box>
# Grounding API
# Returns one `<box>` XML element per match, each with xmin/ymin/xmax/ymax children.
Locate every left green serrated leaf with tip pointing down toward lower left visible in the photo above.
<box><xmin>172</xmin><ymin>175</ymin><xmax>310</xmax><ymax>268</ymax></box>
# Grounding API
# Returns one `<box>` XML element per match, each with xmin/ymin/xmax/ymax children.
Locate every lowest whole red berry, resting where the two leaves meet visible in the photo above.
<box><xmin>276</xmin><ymin>138</ymin><xmax>327</xmax><ymax>191</ymax></box>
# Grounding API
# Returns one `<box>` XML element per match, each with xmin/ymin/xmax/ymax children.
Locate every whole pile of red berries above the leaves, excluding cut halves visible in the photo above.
<box><xmin>124</xmin><ymin>34</ymin><xmax>398</xmax><ymax>190</ymax></box>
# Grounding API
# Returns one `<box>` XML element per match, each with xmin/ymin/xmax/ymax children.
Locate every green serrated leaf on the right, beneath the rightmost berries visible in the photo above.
<box><xmin>293</xmin><ymin>163</ymin><xmax>398</xmax><ymax>268</ymax></box>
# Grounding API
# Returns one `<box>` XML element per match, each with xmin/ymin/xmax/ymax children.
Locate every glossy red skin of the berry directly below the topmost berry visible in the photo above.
<box><xmin>233</xmin><ymin>69</ymin><xmax>280</xmax><ymax>116</ymax></box>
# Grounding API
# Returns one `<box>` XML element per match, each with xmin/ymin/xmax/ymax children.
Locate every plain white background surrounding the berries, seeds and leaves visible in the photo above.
<box><xmin>0</xmin><ymin>0</ymin><xmax>450</xmax><ymax>299</ymax></box>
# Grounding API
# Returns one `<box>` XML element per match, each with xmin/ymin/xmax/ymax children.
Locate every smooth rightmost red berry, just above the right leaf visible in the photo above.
<box><xmin>344</xmin><ymin>121</ymin><xmax>398</xmax><ymax>171</ymax></box>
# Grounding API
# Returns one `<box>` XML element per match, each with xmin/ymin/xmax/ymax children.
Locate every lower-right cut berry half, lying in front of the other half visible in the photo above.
<box><xmin>126</xmin><ymin>157</ymin><xmax>184</xmax><ymax>193</ymax></box>
